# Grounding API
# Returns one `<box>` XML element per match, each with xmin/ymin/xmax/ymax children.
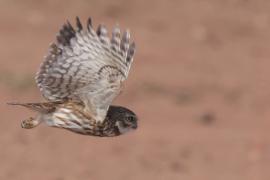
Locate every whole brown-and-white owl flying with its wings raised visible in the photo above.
<box><xmin>9</xmin><ymin>17</ymin><xmax>138</xmax><ymax>137</ymax></box>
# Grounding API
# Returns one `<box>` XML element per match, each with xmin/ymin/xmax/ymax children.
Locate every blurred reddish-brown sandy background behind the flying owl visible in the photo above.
<box><xmin>0</xmin><ymin>0</ymin><xmax>270</xmax><ymax>180</ymax></box>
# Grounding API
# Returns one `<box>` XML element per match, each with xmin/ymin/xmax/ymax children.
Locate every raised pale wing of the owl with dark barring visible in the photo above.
<box><xmin>36</xmin><ymin>17</ymin><xmax>135</xmax><ymax>121</ymax></box>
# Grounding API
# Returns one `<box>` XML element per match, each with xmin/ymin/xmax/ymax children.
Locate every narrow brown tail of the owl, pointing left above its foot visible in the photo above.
<box><xmin>7</xmin><ymin>102</ymin><xmax>59</xmax><ymax>113</ymax></box>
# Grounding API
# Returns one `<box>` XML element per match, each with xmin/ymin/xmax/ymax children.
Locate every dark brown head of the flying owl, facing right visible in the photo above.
<box><xmin>107</xmin><ymin>106</ymin><xmax>138</xmax><ymax>134</ymax></box>
